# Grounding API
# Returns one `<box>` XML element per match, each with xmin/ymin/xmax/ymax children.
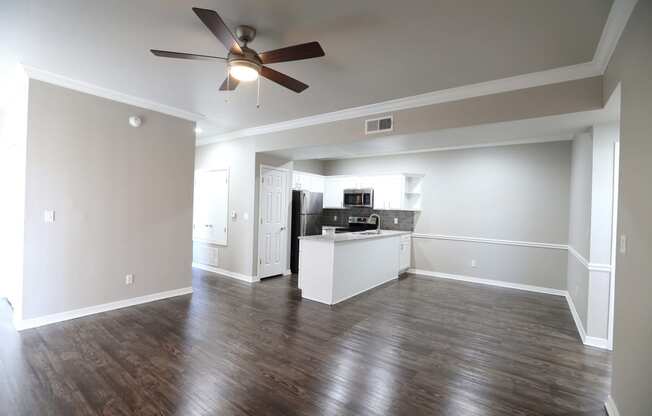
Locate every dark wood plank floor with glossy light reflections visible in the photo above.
<box><xmin>0</xmin><ymin>271</ymin><xmax>611</xmax><ymax>416</ymax></box>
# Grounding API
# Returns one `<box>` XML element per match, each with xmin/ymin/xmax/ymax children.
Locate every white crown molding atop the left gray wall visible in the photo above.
<box><xmin>22</xmin><ymin>65</ymin><xmax>206</xmax><ymax>122</ymax></box>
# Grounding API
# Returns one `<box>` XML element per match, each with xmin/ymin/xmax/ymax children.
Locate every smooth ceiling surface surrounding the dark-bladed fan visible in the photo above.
<box><xmin>0</xmin><ymin>0</ymin><xmax>612</xmax><ymax>134</ymax></box>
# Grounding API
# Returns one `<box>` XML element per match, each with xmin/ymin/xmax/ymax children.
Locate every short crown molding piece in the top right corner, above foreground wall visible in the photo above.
<box><xmin>592</xmin><ymin>0</ymin><xmax>638</xmax><ymax>74</ymax></box>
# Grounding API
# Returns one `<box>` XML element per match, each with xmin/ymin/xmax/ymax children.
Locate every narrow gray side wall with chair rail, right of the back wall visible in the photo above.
<box><xmin>566</xmin><ymin>133</ymin><xmax>593</xmax><ymax>329</ymax></box>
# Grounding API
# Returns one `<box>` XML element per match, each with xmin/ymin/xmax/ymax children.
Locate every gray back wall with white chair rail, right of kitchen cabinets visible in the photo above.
<box><xmin>324</xmin><ymin>141</ymin><xmax>571</xmax><ymax>290</ymax></box>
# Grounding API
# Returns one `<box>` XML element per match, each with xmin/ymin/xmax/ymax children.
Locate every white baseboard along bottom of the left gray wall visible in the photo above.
<box><xmin>14</xmin><ymin>287</ymin><xmax>192</xmax><ymax>331</ymax></box>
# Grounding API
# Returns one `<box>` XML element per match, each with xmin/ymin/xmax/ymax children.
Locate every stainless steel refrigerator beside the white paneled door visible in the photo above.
<box><xmin>290</xmin><ymin>191</ymin><xmax>324</xmax><ymax>273</ymax></box>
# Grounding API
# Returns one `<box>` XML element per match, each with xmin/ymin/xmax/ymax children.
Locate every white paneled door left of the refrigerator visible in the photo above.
<box><xmin>258</xmin><ymin>167</ymin><xmax>288</xmax><ymax>278</ymax></box>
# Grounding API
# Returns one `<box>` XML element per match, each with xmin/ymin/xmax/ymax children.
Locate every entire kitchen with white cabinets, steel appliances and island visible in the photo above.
<box><xmin>290</xmin><ymin>170</ymin><xmax>423</xmax><ymax>305</ymax></box>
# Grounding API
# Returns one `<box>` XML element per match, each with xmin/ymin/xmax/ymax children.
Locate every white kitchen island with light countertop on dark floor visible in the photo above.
<box><xmin>299</xmin><ymin>230</ymin><xmax>411</xmax><ymax>305</ymax></box>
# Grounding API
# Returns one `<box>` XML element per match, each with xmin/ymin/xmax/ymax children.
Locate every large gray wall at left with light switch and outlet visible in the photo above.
<box><xmin>23</xmin><ymin>80</ymin><xmax>195</xmax><ymax>319</ymax></box>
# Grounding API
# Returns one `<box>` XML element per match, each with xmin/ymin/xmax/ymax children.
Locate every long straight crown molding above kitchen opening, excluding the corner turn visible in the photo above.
<box><xmin>197</xmin><ymin>62</ymin><xmax>601</xmax><ymax>146</ymax></box>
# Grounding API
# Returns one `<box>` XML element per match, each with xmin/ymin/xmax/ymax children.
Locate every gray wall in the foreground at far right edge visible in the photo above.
<box><xmin>604</xmin><ymin>0</ymin><xmax>652</xmax><ymax>416</ymax></box>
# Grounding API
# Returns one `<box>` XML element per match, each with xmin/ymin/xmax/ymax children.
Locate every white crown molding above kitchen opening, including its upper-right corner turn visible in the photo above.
<box><xmin>197</xmin><ymin>0</ymin><xmax>638</xmax><ymax>146</ymax></box>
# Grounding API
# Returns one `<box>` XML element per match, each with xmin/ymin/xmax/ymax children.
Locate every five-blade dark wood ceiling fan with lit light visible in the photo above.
<box><xmin>151</xmin><ymin>7</ymin><xmax>325</xmax><ymax>93</ymax></box>
